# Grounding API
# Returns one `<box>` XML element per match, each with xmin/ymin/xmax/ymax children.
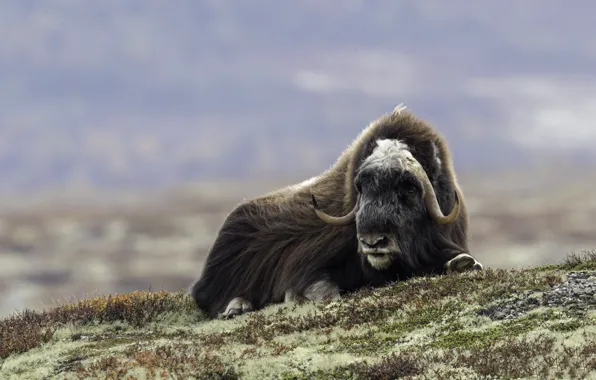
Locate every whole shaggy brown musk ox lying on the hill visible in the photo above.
<box><xmin>189</xmin><ymin>104</ymin><xmax>482</xmax><ymax>318</ymax></box>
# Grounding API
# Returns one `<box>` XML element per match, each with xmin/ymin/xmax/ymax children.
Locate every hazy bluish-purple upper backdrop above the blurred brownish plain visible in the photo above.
<box><xmin>0</xmin><ymin>0</ymin><xmax>596</xmax><ymax>192</ymax></box>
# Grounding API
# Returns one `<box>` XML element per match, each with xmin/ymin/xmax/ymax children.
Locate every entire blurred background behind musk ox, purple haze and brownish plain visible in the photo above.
<box><xmin>0</xmin><ymin>0</ymin><xmax>596</xmax><ymax>318</ymax></box>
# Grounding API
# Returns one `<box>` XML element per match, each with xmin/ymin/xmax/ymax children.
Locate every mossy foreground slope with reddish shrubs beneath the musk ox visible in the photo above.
<box><xmin>0</xmin><ymin>252</ymin><xmax>596</xmax><ymax>379</ymax></box>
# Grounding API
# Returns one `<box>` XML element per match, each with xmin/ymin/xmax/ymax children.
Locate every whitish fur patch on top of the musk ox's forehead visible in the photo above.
<box><xmin>361</xmin><ymin>139</ymin><xmax>416</xmax><ymax>169</ymax></box>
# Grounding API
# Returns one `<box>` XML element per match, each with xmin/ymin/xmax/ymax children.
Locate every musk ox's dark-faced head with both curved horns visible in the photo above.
<box><xmin>313</xmin><ymin>139</ymin><xmax>460</xmax><ymax>270</ymax></box>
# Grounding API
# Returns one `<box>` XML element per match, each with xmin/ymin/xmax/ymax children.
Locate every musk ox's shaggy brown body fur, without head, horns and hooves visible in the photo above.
<box><xmin>190</xmin><ymin>107</ymin><xmax>468</xmax><ymax>318</ymax></box>
